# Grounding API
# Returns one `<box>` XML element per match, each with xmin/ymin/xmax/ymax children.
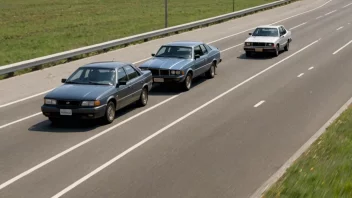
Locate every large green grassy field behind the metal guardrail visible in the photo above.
<box><xmin>0</xmin><ymin>0</ymin><xmax>274</xmax><ymax>65</ymax></box>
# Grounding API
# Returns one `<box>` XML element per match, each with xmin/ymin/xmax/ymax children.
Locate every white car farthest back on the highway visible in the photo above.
<box><xmin>244</xmin><ymin>25</ymin><xmax>292</xmax><ymax>57</ymax></box>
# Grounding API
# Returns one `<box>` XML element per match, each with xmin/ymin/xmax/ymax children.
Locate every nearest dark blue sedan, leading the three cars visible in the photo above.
<box><xmin>41</xmin><ymin>61</ymin><xmax>152</xmax><ymax>123</ymax></box>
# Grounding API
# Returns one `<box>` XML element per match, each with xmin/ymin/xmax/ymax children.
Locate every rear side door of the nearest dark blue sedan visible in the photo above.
<box><xmin>124</xmin><ymin>65</ymin><xmax>143</xmax><ymax>103</ymax></box>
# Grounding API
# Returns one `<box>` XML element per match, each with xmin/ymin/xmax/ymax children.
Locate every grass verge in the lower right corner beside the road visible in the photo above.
<box><xmin>264</xmin><ymin>107</ymin><xmax>352</xmax><ymax>198</ymax></box>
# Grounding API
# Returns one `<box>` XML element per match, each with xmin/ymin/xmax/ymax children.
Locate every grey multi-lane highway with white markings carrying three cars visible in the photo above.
<box><xmin>0</xmin><ymin>0</ymin><xmax>352</xmax><ymax>198</ymax></box>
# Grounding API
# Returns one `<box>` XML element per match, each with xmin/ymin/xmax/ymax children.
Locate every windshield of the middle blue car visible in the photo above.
<box><xmin>155</xmin><ymin>46</ymin><xmax>192</xmax><ymax>59</ymax></box>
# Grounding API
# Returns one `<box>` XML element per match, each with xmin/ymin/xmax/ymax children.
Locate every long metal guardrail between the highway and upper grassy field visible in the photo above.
<box><xmin>0</xmin><ymin>0</ymin><xmax>294</xmax><ymax>75</ymax></box>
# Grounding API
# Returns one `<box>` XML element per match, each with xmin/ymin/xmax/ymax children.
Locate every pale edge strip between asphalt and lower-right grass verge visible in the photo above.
<box><xmin>250</xmin><ymin>95</ymin><xmax>352</xmax><ymax>198</ymax></box>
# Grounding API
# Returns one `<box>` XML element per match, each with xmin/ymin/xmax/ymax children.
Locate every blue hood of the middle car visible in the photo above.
<box><xmin>140</xmin><ymin>57</ymin><xmax>192</xmax><ymax>70</ymax></box>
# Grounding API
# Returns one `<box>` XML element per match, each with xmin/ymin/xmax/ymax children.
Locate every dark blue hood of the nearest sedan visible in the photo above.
<box><xmin>45</xmin><ymin>84</ymin><xmax>114</xmax><ymax>100</ymax></box>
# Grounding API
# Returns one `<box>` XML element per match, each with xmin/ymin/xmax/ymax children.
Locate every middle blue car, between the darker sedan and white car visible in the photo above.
<box><xmin>139</xmin><ymin>41</ymin><xmax>221</xmax><ymax>90</ymax></box>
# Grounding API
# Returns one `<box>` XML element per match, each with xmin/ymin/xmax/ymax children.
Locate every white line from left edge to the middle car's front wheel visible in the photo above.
<box><xmin>0</xmin><ymin>94</ymin><xmax>180</xmax><ymax>190</ymax></box>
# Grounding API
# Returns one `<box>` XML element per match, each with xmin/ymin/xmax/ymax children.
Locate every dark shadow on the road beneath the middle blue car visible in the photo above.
<box><xmin>149</xmin><ymin>75</ymin><xmax>208</xmax><ymax>96</ymax></box>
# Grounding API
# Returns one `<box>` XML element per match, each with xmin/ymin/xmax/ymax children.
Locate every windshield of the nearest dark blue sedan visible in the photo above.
<box><xmin>66</xmin><ymin>67</ymin><xmax>116</xmax><ymax>85</ymax></box>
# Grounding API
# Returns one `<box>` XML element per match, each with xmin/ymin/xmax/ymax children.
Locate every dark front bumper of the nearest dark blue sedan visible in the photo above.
<box><xmin>41</xmin><ymin>105</ymin><xmax>106</xmax><ymax>119</ymax></box>
